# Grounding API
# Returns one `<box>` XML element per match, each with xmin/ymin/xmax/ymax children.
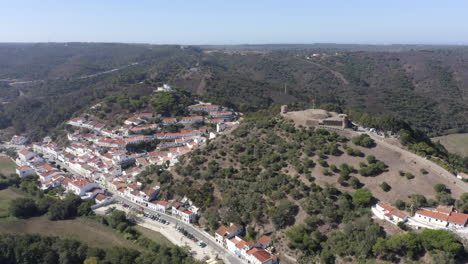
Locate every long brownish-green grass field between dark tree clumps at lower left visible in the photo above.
<box><xmin>0</xmin><ymin>217</ymin><xmax>141</xmax><ymax>250</ymax></box>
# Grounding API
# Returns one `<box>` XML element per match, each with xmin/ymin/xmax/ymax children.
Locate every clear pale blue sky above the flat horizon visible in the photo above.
<box><xmin>0</xmin><ymin>0</ymin><xmax>468</xmax><ymax>44</ymax></box>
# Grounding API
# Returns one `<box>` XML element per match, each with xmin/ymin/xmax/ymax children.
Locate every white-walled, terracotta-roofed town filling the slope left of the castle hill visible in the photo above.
<box><xmin>6</xmin><ymin>85</ymin><xmax>277</xmax><ymax>263</ymax></box>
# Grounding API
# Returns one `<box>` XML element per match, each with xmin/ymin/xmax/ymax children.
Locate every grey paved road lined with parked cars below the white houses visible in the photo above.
<box><xmin>114</xmin><ymin>195</ymin><xmax>243</xmax><ymax>264</ymax></box>
